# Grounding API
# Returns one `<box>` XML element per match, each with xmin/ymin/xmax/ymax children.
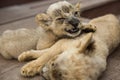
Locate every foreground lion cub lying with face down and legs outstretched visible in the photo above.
<box><xmin>19</xmin><ymin>14</ymin><xmax>120</xmax><ymax>80</ymax></box>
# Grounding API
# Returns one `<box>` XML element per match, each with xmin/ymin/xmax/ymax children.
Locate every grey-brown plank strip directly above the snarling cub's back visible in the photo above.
<box><xmin>0</xmin><ymin>17</ymin><xmax>38</xmax><ymax>34</ymax></box>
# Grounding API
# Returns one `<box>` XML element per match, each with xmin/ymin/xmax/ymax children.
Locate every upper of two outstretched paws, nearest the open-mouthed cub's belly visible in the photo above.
<box><xmin>18</xmin><ymin>51</ymin><xmax>32</xmax><ymax>62</ymax></box>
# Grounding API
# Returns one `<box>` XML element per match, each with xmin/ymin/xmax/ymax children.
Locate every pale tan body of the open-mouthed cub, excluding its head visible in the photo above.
<box><xmin>0</xmin><ymin>25</ymin><xmax>55</xmax><ymax>59</ymax></box>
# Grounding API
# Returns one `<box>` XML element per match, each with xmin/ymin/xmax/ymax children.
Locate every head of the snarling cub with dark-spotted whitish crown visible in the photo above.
<box><xmin>36</xmin><ymin>1</ymin><xmax>82</xmax><ymax>37</ymax></box>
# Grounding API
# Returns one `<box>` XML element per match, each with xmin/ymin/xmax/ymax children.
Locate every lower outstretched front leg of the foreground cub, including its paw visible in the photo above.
<box><xmin>21</xmin><ymin>50</ymin><xmax>60</xmax><ymax>76</ymax></box>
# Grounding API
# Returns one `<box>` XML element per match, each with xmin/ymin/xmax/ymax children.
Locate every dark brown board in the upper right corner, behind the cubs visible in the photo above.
<box><xmin>81</xmin><ymin>0</ymin><xmax>120</xmax><ymax>19</ymax></box>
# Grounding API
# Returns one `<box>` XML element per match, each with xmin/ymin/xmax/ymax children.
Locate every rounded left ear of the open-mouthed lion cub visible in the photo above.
<box><xmin>35</xmin><ymin>13</ymin><xmax>52</xmax><ymax>29</ymax></box>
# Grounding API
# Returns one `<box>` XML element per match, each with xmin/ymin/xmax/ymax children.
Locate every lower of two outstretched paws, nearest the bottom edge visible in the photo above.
<box><xmin>21</xmin><ymin>61</ymin><xmax>39</xmax><ymax>77</ymax></box>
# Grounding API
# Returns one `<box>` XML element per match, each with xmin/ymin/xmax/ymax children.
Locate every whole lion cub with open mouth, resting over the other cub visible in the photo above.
<box><xmin>0</xmin><ymin>1</ymin><xmax>95</xmax><ymax>59</ymax></box>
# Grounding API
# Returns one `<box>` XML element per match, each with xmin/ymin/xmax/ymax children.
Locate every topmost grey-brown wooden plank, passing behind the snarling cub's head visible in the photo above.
<box><xmin>0</xmin><ymin>0</ymin><xmax>113</xmax><ymax>24</ymax></box>
